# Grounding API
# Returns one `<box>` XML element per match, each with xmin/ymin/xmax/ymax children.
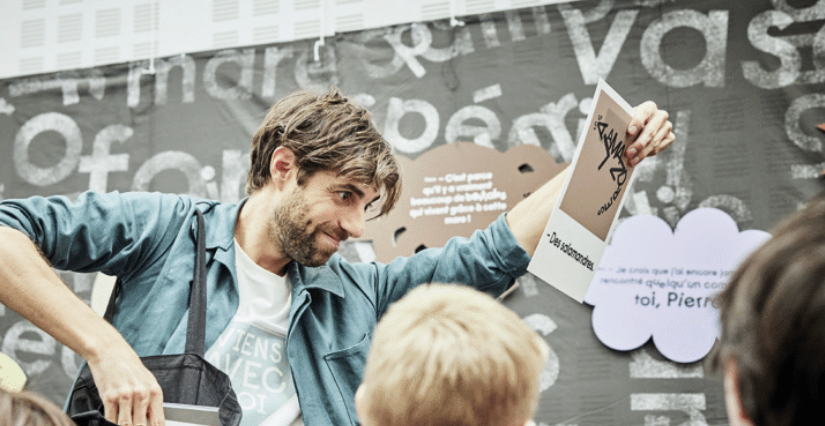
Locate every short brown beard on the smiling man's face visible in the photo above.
<box><xmin>270</xmin><ymin>188</ymin><xmax>345</xmax><ymax>267</ymax></box>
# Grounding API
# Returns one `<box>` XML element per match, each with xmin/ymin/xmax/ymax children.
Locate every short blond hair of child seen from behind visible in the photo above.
<box><xmin>360</xmin><ymin>284</ymin><xmax>549</xmax><ymax>426</ymax></box>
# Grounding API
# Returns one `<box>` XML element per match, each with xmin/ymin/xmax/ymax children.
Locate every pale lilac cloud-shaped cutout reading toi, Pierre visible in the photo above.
<box><xmin>585</xmin><ymin>208</ymin><xmax>770</xmax><ymax>363</ymax></box>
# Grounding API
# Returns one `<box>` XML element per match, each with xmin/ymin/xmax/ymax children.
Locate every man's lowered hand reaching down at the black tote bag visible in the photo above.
<box><xmin>88</xmin><ymin>342</ymin><xmax>166</xmax><ymax>426</ymax></box>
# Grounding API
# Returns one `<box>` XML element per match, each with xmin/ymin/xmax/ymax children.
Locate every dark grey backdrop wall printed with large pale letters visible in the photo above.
<box><xmin>0</xmin><ymin>0</ymin><xmax>825</xmax><ymax>426</ymax></box>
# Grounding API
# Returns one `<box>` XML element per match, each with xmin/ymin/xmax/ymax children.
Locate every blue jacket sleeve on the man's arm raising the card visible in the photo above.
<box><xmin>338</xmin><ymin>214</ymin><xmax>530</xmax><ymax>317</ymax></box>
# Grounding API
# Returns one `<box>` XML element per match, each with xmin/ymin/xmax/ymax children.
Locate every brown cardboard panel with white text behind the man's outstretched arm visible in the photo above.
<box><xmin>360</xmin><ymin>142</ymin><xmax>567</xmax><ymax>262</ymax></box>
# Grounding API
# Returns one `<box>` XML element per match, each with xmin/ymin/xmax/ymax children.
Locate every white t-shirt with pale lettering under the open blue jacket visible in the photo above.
<box><xmin>206</xmin><ymin>241</ymin><xmax>303</xmax><ymax>426</ymax></box>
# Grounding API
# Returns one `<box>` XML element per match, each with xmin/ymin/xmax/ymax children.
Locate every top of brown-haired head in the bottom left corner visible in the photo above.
<box><xmin>0</xmin><ymin>390</ymin><xmax>74</xmax><ymax>426</ymax></box>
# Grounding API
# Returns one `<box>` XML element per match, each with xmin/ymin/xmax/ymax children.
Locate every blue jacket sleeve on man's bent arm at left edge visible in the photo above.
<box><xmin>0</xmin><ymin>192</ymin><xmax>192</xmax><ymax>276</ymax></box>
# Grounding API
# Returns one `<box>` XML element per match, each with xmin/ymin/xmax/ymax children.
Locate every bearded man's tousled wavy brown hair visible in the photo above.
<box><xmin>246</xmin><ymin>88</ymin><xmax>401</xmax><ymax>216</ymax></box>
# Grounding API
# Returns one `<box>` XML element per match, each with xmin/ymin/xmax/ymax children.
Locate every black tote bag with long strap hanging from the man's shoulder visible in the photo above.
<box><xmin>66</xmin><ymin>208</ymin><xmax>242</xmax><ymax>426</ymax></box>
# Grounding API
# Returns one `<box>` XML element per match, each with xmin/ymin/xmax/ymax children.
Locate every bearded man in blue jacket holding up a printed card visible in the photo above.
<box><xmin>0</xmin><ymin>89</ymin><xmax>674</xmax><ymax>426</ymax></box>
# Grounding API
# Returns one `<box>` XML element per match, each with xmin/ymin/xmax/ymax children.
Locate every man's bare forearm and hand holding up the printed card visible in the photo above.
<box><xmin>507</xmin><ymin>101</ymin><xmax>675</xmax><ymax>256</ymax></box>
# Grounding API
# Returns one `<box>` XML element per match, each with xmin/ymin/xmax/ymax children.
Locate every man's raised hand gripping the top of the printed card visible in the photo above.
<box><xmin>625</xmin><ymin>101</ymin><xmax>676</xmax><ymax>167</ymax></box>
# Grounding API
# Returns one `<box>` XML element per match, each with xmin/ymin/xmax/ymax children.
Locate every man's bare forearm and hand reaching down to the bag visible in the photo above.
<box><xmin>0</xmin><ymin>226</ymin><xmax>165</xmax><ymax>426</ymax></box>
